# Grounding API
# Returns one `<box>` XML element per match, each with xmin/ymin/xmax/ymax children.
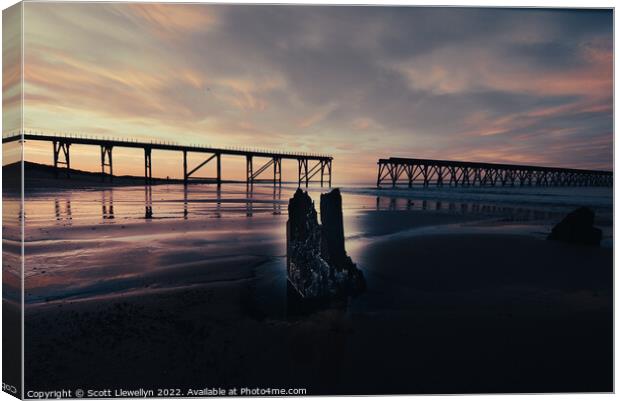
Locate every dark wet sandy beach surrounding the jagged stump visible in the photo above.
<box><xmin>18</xmin><ymin>184</ymin><xmax>613</xmax><ymax>395</ymax></box>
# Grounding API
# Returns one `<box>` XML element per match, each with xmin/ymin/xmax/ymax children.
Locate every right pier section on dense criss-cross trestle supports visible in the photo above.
<box><xmin>377</xmin><ymin>157</ymin><xmax>613</xmax><ymax>188</ymax></box>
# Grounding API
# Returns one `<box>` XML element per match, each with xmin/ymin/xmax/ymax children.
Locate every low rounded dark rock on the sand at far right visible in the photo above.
<box><xmin>547</xmin><ymin>207</ymin><xmax>603</xmax><ymax>246</ymax></box>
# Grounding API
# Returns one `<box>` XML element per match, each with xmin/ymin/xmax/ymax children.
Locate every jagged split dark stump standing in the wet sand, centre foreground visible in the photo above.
<box><xmin>286</xmin><ymin>189</ymin><xmax>365</xmax><ymax>299</ymax></box>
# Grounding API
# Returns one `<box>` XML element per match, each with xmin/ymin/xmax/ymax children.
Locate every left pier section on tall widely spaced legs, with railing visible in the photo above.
<box><xmin>2</xmin><ymin>132</ymin><xmax>333</xmax><ymax>187</ymax></box>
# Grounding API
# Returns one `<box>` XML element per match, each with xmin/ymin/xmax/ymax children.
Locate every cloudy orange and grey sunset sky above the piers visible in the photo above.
<box><xmin>4</xmin><ymin>3</ymin><xmax>613</xmax><ymax>182</ymax></box>
